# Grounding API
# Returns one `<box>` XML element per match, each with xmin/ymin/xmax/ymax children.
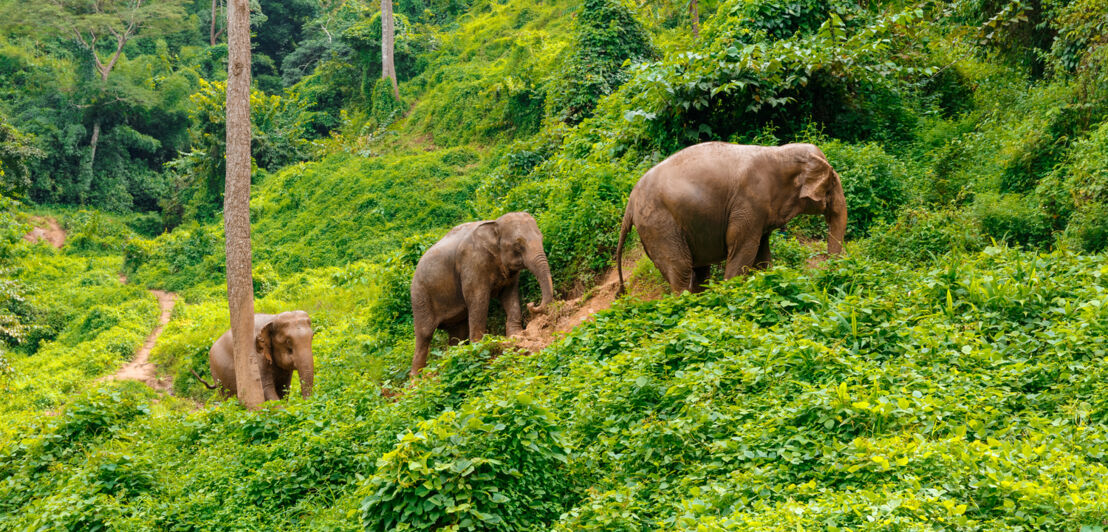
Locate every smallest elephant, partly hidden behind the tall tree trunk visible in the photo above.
<box><xmin>193</xmin><ymin>310</ymin><xmax>316</xmax><ymax>401</ymax></box>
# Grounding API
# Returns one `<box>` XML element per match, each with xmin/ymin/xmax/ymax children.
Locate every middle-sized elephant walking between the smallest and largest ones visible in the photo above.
<box><xmin>411</xmin><ymin>213</ymin><xmax>554</xmax><ymax>376</ymax></box>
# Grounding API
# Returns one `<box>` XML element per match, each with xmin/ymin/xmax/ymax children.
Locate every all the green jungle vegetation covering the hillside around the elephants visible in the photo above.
<box><xmin>0</xmin><ymin>0</ymin><xmax>1108</xmax><ymax>531</ymax></box>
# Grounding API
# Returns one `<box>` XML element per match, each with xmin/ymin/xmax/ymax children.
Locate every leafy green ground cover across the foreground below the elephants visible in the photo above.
<box><xmin>0</xmin><ymin>247</ymin><xmax>1108</xmax><ymax>530</ymax></box>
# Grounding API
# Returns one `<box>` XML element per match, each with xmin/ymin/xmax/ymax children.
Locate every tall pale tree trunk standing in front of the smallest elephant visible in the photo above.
<box><xmin>223</xmin><ymin>0</ymin><xmax>265</xmax><ymax>409</ymax></box>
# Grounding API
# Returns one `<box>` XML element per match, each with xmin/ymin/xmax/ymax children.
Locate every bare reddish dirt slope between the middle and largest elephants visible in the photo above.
<box><xmin>514</xmin><ymin>247</ymin><xmax>668</xmax><ymax>351</ymax></box>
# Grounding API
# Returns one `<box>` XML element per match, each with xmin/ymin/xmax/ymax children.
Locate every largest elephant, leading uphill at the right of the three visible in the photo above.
<box><xmin>616</xmin><ymin>142</ymin><xmax>847</xmax><ymax>293</ymax></box>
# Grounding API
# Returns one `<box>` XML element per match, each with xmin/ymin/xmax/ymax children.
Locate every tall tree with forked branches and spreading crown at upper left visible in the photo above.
<box><xmin>20</xmin><ymin>0</ymin><xmax>187</xmax><ymax>175</ymax></box>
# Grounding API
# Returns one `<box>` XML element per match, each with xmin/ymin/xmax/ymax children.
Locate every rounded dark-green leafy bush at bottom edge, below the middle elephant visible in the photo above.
<box><xmin>361</xmin><ymin>387</ymin><xmax>568</xmax><ymax>531</ymax></box>
